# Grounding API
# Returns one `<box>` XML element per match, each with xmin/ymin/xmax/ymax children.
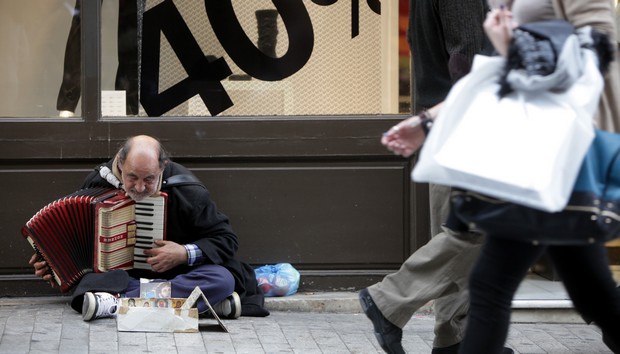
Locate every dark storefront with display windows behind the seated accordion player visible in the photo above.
<box><xmin>0</xmin><ymin>0</ymin><xmax>429</xmax><ymax>296</ymax></box>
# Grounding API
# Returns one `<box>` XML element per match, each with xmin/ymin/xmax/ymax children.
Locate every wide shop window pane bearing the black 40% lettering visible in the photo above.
<box><xmin>102</xmin><ymin>0</ymin><xmax>409</xmax><ymax>117</ymax></box>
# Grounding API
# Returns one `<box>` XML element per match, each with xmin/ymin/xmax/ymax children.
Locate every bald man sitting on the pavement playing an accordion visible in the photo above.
<box><xmin>30</xmin><ymin>135</ymin><xmax>269</xmax><ymax>321</ymax></box>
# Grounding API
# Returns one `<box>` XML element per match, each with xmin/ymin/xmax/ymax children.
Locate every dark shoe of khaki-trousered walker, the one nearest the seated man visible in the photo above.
<box><xmin>358</xmin><ymin>289</ymin><xmax>405</xmax><ymax>354</ymax></box>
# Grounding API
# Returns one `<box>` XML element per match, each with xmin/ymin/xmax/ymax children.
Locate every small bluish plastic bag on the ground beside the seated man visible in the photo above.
<box><xmin>255</xmin><ymin>263</ymin><xmax>299</xmax><ymax>296</ymax></box>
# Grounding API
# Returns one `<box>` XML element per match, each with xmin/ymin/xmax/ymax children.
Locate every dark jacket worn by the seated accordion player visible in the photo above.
<box><xmin>74</xmin><ymin>161</ymin><xmax>269</xmax><ymax>316</ymax></box>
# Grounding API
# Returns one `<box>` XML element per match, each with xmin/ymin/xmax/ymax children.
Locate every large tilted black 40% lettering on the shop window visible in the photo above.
<box><xmin>140</xmin><ymin>0</ymin><xmax>380</xmax><ymax>116</ymax></box>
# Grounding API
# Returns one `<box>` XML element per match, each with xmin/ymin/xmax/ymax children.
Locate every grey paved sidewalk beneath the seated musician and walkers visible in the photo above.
<box><xmin>0</xmin><ymin>292</ymin><xmax>611</xmax><ymax>354</ymax></box>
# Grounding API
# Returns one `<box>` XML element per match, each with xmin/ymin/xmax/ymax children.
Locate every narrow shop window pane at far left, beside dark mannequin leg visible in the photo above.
<box><xmin>0</xmin><ymin>0</ymin><xmax>80</xmax><ymax>117</ymax></box>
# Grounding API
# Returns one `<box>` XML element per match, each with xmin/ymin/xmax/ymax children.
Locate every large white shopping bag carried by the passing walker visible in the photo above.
<box><xmin>412</xmin><ymin>51</ymin><xmax>603</xmax><ymax>212</ymax></box>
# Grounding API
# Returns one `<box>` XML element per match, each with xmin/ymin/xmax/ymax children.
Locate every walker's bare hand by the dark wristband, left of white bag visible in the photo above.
<box><xmin>381</xmin><ymin>116</ymin><xmax>426</xmax><ymax>157</ymax></box>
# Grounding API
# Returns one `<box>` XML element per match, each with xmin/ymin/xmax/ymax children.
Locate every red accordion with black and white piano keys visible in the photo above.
<box><xmin>22</xmin><ymin>188</ymin><xmax>167</xmax><ymax>292</ymax></box>
